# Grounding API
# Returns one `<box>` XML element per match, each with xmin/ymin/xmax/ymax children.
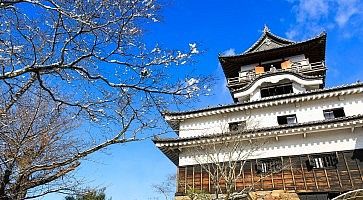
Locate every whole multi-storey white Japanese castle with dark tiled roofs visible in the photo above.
<box><xmin>154</xmin><ymin>27</ymin><xmax>363</xmax><ymax>199</ymax></box>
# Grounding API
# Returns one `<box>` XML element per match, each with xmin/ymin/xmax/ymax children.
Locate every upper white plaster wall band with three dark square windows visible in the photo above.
<box><xmin>179</xmin><ymin>94</ymin><xmax>363</xmax><ymax>138</ymax></box>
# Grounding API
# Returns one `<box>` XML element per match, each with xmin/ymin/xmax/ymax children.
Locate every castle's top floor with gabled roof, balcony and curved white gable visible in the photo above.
<box><xmin>219</xmin><ymin>27</ymin><xmax>326</xmax><ymax>102</ymax></box>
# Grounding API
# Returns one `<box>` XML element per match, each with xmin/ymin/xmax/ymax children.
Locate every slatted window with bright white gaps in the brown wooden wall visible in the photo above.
<box><xmin>307</xmin><ymin>153</ymin><xmax>338</xmax><ymax>170</ymax></box>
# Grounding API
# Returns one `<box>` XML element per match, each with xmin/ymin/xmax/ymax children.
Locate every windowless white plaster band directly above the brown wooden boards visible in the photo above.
<box><xmin>179</xmin><ymin>127</ymin><xmax>363</xmax><ymax>166</ymax></box>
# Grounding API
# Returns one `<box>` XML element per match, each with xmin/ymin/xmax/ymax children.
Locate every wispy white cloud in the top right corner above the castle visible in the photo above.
<box><xmin>285</xmin><ymin>0</ymin><xmax>363</xmax><ymax>39</ymax></box>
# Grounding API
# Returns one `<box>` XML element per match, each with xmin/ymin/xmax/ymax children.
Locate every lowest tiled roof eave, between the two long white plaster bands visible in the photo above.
<box><xmin>153</xmin><ymin>115</ymin><xmax>363</xmax><ymax>166</ymax></box>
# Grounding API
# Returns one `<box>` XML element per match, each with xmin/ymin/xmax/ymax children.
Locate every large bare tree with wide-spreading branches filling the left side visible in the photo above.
<box><xmin>0</xmin><ymin>0</ymin><xmax>211</xmax><ymax>199</ymax></box>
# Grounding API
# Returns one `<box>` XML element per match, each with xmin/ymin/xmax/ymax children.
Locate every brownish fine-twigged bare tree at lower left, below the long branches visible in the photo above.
<box><xmin>0</xmin><ymin>93</ymin><xmax>82</xmax><ymax>200</ymax></box>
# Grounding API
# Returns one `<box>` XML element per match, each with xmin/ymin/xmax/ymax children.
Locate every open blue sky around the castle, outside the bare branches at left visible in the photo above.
<box><xmin>44</xmin><ymin>0</ymin><xmax>363</xmax><ymax>200</ymax></box>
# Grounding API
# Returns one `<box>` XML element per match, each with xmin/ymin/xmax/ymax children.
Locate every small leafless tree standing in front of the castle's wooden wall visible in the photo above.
<box><xmin>182</xmin><ymin>127</ymin><xmax>286</xmax><ymax>200</ymax></box>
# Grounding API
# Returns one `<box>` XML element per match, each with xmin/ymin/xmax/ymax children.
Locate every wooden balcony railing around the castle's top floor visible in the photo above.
<box><xmin>227</xmin><ymin>59</ymin><xmax>326</xmax><ymax>86</ymax></box>
